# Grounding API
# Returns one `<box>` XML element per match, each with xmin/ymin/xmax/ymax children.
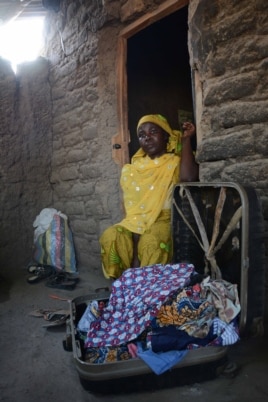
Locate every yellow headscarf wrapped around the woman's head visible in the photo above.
<box><xmin>137</xmin><ymin>114</ymin><xmax>181</xmax><ymax>154</ymax></box>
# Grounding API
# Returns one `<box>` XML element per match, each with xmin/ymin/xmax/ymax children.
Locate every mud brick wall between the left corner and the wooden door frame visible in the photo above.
<box><xmin>43</xmin><ymin>1</ymin><xmax>122</xmax><ymax>271</ymax></box>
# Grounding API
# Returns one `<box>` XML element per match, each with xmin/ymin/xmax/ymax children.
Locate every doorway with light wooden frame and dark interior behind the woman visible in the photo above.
<box><xmin>112</xmin><ymin>0</ymin><xmax>193</xmax><ymax>166</ymax></box>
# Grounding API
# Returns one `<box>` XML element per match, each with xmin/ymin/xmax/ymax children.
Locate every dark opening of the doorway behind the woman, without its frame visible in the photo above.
<box><xmin>127</xmin><ymin>6</ymin><xmax>193</xmax><ymax>157</ymax></box>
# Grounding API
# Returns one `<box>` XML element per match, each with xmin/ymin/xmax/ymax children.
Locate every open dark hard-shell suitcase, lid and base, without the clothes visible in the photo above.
<box><xmin>64</xmin><ymin>182</ymin><xmax>264</xmax><ymax>392</ymax></box>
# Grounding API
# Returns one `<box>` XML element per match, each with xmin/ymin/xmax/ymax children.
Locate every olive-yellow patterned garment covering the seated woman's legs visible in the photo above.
<box><xmin>100</xmin><ymin>211</ymin><xmax>172</xmax><ymax>278</ymax></box>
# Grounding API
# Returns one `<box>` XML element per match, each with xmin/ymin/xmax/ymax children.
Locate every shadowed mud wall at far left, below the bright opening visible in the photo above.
<box><xmin>0</xmin><ymin>58</ymin><xmax>52</xmax><ymax>267</ymax></box>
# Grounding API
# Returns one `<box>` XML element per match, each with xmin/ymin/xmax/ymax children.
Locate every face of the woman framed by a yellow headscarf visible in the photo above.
<box><xmin>138</xmin><ymin>123</ymin><xmax>169</xmax><ymax>159</ymax></box>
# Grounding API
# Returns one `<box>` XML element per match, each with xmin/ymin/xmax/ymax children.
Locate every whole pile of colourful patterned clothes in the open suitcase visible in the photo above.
<box><xmin>77</xmin><ymin>263</ymin><xmax>240</xmax><ymax>374</ymax></box>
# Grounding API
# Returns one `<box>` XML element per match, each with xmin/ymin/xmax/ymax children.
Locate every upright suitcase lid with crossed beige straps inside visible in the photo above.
<box><xmin>171</xmin><ymin>182</ymin><xmax>249</xmax><ymax>331</ymax></box>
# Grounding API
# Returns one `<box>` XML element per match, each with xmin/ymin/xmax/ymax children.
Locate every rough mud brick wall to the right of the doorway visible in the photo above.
<box><xmin>189</xmin><ymin>0</ymin><xmax>268</xmax><ymax>262</ymax></box>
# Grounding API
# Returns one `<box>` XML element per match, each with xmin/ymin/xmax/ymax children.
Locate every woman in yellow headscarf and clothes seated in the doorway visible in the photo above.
<box><xmin>100</xmin><ymin>115</ymin><xmax>198</xmax><ymax>279</ymax></box>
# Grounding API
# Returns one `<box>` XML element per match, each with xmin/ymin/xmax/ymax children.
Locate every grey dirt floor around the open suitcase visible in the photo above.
<box><xmin>0</xmin><ymin>267</ymin><xmax>268</xmax><ymax>402</ymax></box>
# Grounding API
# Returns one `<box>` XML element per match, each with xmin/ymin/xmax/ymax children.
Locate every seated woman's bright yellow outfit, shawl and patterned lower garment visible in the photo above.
<box><xmin>100</xmin><ymin>152</ymin><xmax>180</xmax><ymax>278</ymax></box>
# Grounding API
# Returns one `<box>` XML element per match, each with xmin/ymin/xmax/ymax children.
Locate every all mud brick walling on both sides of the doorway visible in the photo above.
<box><xmin>0</xmin><ymin>0</ymin><xmax>268</xmax><ymax>273</ymax></box>
